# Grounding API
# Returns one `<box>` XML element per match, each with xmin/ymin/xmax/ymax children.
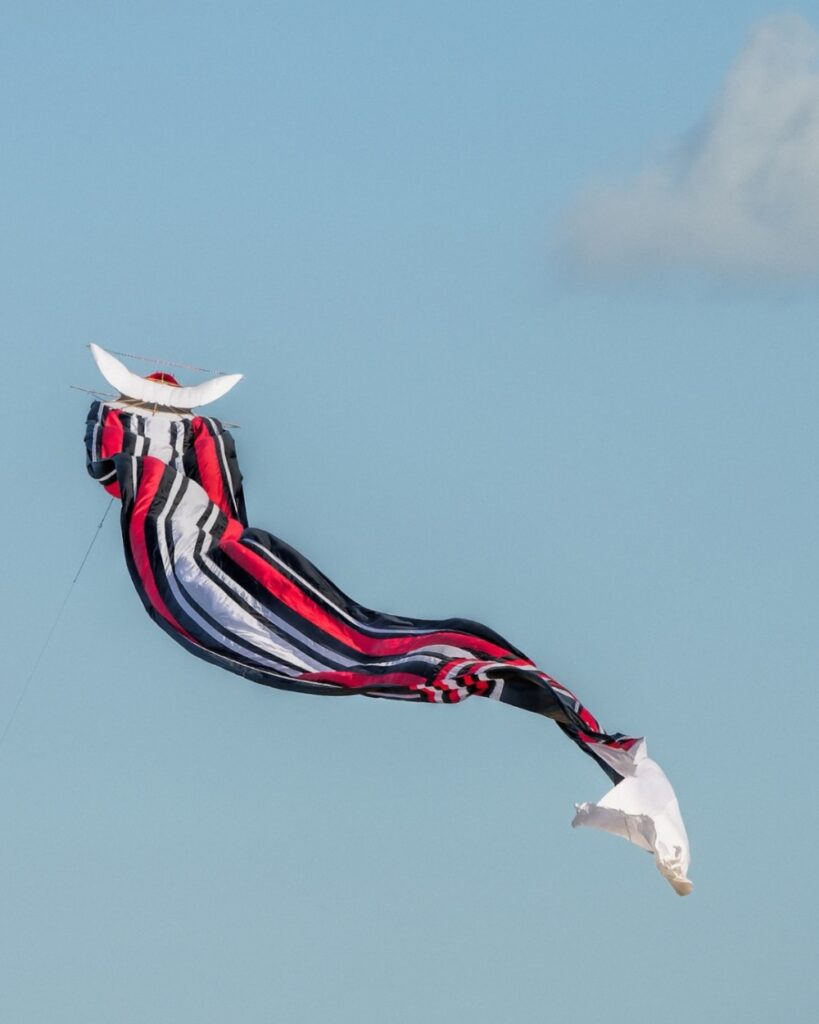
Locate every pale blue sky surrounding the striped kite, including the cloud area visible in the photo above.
<box><xmin>0</xmin><ymin>2</ymin><xmax>819</xmax><ymax>1024</ymax></box>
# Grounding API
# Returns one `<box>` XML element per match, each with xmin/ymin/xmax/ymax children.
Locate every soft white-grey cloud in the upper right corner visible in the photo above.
<box><xmin>563</xmin><ymin>14</ymin><xmax>819</xmax><ymax>280</ymax></box>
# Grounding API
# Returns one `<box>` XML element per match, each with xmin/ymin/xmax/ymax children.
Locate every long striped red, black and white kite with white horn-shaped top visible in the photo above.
<box><xmin>85</xmin><ymin>345</ymin><xmax>692</xmax><ymax>895</ymax></box>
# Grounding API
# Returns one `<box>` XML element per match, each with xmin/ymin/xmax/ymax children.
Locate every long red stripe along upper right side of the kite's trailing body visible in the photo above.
<box><xmin>219</xmin><ymin>520</ymin><xmax>509</xmax><ymax>657</ymax></box>
